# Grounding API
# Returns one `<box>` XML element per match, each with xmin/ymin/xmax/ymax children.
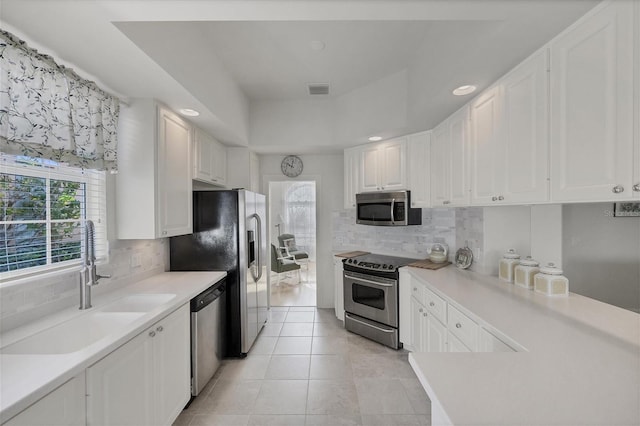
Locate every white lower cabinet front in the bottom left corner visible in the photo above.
<box><xmin>3</xmin><ymin>373</ymin><xmax>86</xmax><ymax>426</ymax></box>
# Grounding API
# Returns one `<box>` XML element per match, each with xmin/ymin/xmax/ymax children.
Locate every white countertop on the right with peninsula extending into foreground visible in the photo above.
<box><xmin>407</xmin><ymin>266</ymin><xmax>640</xmax><ymax>425</ymax></box>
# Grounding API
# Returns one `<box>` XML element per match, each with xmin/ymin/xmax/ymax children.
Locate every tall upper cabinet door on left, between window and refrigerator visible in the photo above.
<box><xmin>157</xmin><ymin>108</ymin><xmax>193</xmax><ymax>237</ymax></box>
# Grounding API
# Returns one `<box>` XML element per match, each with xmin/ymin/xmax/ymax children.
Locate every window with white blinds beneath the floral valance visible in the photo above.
<box><xmin>0</xmin><ymin>155</ymin><xmax>108</xmax><ymax>279</ymax></box>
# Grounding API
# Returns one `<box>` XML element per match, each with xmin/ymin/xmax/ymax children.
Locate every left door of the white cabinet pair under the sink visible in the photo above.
<box><xmin>86</xmin><ymin>333</ymin><xmax>155</xmax><ymax>426</ymax></box>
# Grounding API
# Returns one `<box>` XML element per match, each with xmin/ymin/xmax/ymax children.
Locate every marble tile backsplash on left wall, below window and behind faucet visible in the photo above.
<box><xmin>0</xmin><ymin>239</ymin><xmax>169</xmax><ymax>331</ymax></box>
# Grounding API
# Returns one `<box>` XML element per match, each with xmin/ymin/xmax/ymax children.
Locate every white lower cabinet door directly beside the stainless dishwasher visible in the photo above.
<box><xmin>152</xmin><ymin>304</ymin><xmax>191</xmax><ymax>424</ymax></box>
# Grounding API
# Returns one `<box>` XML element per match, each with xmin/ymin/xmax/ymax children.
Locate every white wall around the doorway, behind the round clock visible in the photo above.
<box><xmin>260</xmin><ymin>154</ymin><xmax>344</xmax><ymax>308</ymax></box>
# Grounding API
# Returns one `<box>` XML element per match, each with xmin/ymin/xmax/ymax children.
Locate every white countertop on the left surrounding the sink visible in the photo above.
<box><xmin>0</xmin><ymin>272</ymin><xmax>227</xmax><ymax>423</ymax></box>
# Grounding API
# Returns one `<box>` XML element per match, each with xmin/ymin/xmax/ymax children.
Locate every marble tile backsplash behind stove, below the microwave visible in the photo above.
<box><xmin>332</xmin><ymin>207</ymin><xmax>483</xmax><ymax>266</ymax></box>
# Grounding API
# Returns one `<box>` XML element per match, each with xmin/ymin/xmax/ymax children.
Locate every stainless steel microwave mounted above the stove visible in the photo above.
<box><xmin>356</xmin><ymin>191</ymin><xmax>422</xmax><ymax>226</ymax></box>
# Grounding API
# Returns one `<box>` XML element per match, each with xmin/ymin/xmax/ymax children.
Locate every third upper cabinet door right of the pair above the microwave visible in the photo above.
<box><xmin>446</xmin><ymin>108</ymin><xmax>469</xmax><ymax>206</ymax></box>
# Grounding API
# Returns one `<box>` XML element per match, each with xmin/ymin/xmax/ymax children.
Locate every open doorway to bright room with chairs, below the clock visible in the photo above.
<box><xmin>269</xmin><ymin>181</ymin><xmax>317</xmax><ymax>306</ymax></box>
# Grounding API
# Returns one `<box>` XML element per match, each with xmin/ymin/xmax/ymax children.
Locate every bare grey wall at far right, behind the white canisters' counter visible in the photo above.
<box><xmin>562</xmin><ymin>203</ymin><xmax>640</xmax><ymax>312</ymax></box>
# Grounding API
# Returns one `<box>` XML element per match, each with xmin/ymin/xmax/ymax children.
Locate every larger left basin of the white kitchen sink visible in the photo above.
<box><xmin>0</xmin><ymin>311</ymin><xmax>144</xmax><ymax>355</ymax></box>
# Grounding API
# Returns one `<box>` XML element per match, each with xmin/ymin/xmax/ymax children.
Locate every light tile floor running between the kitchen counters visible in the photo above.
<box><xmin>174</xmin><ymin>307</ymin><xmax>431</xmax><ymax>426</ymax></box>
